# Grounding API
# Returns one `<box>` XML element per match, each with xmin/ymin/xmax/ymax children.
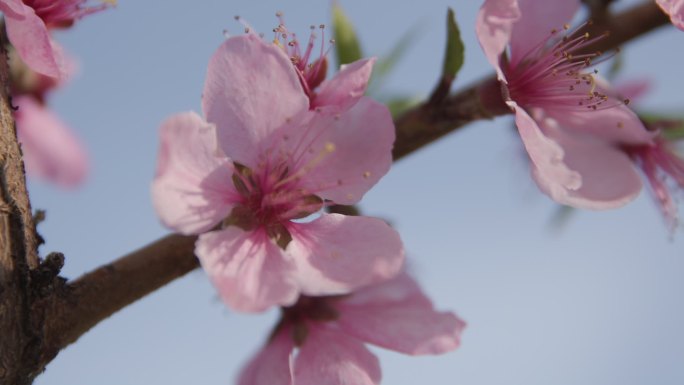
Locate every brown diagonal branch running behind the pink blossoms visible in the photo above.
<box><xmin>25</xmin><ymin>1</ymin><xmax>668</xmax><ymax>378</ymax></box>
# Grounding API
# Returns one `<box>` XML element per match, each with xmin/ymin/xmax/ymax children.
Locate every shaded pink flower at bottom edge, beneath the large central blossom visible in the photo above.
<box><xmin>238</xmin><ymin>274</ymin><xmax>465</xmax><ymax>385</ymax></box>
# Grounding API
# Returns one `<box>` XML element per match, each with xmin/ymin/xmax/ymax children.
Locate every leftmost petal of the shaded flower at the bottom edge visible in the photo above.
<box><xmin>238</xmin><ymin>331</ymin><xmax>294</xmax><ymax>385</ymax></box>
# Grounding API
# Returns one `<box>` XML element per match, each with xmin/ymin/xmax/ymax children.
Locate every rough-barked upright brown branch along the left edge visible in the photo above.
<box><xmin>0</xmin><ymin>38</ymin><xmax>42</xmax><ymax>385</ymax></box>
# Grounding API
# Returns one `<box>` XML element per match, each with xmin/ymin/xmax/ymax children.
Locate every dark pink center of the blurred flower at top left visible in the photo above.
<box><xmin>23</xmin><ymin>0</ymin><xmax>116</xmax><ymax>28</ymax></box>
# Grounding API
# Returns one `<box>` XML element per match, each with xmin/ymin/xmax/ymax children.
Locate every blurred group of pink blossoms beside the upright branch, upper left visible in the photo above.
<box><xmin>0</xmin><ymin>0</ymin><xmax>114</xmax><ymax>187</ymax></box>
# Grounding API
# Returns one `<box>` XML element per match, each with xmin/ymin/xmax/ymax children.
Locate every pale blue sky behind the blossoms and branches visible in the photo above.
<box><xmin>29</xmin><ymin>0</ymin><xmax>684</xmax><ymax>385</ymax></box>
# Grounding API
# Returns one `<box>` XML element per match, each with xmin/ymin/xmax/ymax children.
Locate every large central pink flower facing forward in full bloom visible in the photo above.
<box><xmin>152</xmin><ymin>34</ymin><xmax>404</xmax><ymax>311</ymax></box>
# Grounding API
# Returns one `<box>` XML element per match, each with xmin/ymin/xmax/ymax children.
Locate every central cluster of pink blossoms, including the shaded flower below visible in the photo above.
<box><xmin>152</xmin><ymin>20</ymin><xmax>464</xmax><ymax>385</ymax></box>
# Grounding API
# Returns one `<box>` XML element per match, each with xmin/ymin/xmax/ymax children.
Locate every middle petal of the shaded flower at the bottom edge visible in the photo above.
<box><xmin>294</xmin><ymin>328</ymin><xmax>381</xmax><ymax>385</ymax></box>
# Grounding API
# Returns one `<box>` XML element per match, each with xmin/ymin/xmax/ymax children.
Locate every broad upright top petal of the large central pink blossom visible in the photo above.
<box><xmin>202</xmin><ymin>34</ymin><xmax>309</xmax><ymax>169</ymax></box>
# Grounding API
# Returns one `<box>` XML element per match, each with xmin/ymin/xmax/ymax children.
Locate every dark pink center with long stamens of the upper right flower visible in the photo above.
<box><xmin>502</xmin><ymin>25</ymin><xmax>628</xmax><ymax>110</ymax></box>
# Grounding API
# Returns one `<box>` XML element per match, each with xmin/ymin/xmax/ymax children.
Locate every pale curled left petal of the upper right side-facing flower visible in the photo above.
<box><xmin>506</xmin><ymin>101</ymin><xmax>582</xmax><ymax>197</ymax></box>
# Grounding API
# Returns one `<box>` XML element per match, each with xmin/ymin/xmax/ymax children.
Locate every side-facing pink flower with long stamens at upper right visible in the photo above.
<box><xmin>476</xmin><ymin>0</ymin><xmax>652</xmax><ymax>209</ymax></box>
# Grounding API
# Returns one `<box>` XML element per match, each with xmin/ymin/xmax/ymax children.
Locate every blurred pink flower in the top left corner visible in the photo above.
<box><xmin>0</xmin><ymin>0</ymin><xmax>114</xmax><ymax>78</ymax></box>
